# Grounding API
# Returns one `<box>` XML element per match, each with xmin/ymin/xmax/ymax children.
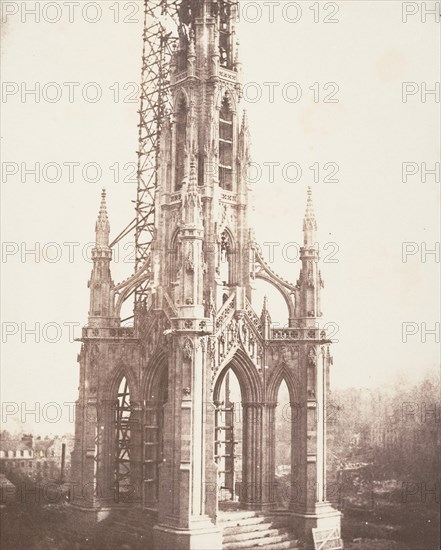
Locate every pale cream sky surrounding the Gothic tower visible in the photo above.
<box><xmin>1</xmin><ymin>0</ymin><xmax>440</xmax><ymax>433</ymax></box>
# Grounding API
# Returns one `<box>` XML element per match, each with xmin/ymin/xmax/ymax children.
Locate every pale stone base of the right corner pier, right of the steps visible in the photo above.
<box><xmin>291</xmin><ymin>502</ymin><xmax>341</xmax><ymax>549</ymax></box>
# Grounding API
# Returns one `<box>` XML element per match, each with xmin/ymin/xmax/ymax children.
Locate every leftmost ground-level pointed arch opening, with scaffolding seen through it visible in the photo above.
<box><xmin>114</xmin><ymin>376</ymin><xmax>132</xmax><ymax>501</ymax></box>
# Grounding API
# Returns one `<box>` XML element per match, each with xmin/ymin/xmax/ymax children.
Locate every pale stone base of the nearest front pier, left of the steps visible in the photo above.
<box><xmin>153</xmin><ymin>522</ymin><xmax>222</xmax><ymax>550</ymax></box>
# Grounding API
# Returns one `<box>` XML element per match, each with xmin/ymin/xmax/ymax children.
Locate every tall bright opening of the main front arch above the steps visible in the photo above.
<box><xmin>214</xmin><ymin>368</ymin><xmax>243</xmax><ymax>508</ymax></box>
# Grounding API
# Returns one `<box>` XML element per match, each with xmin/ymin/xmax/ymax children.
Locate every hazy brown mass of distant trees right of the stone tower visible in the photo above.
<box><xmin>327</xmin><ymin>373</ymin><xmax>441</xmax><ymax>486</ymax></box>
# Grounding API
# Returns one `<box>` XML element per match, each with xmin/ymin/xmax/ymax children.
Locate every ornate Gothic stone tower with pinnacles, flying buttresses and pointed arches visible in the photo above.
<box><xmin>72</xmin><ymin>0</ymin><xmax>340</xmax><ymax>550</ymax></box>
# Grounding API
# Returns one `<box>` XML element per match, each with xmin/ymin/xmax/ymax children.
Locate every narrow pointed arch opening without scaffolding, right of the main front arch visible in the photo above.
<box><xmin>274</xmin><ymin>379</ymin><xmax>292</xmax><ymax>509</ymax></box>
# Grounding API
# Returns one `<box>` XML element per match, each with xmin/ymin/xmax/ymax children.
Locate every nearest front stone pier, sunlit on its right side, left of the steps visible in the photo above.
<box><xmin>154</xmin><ymin>330</ymin><xmax>222</xmax><ymax>550</ymax></box>
